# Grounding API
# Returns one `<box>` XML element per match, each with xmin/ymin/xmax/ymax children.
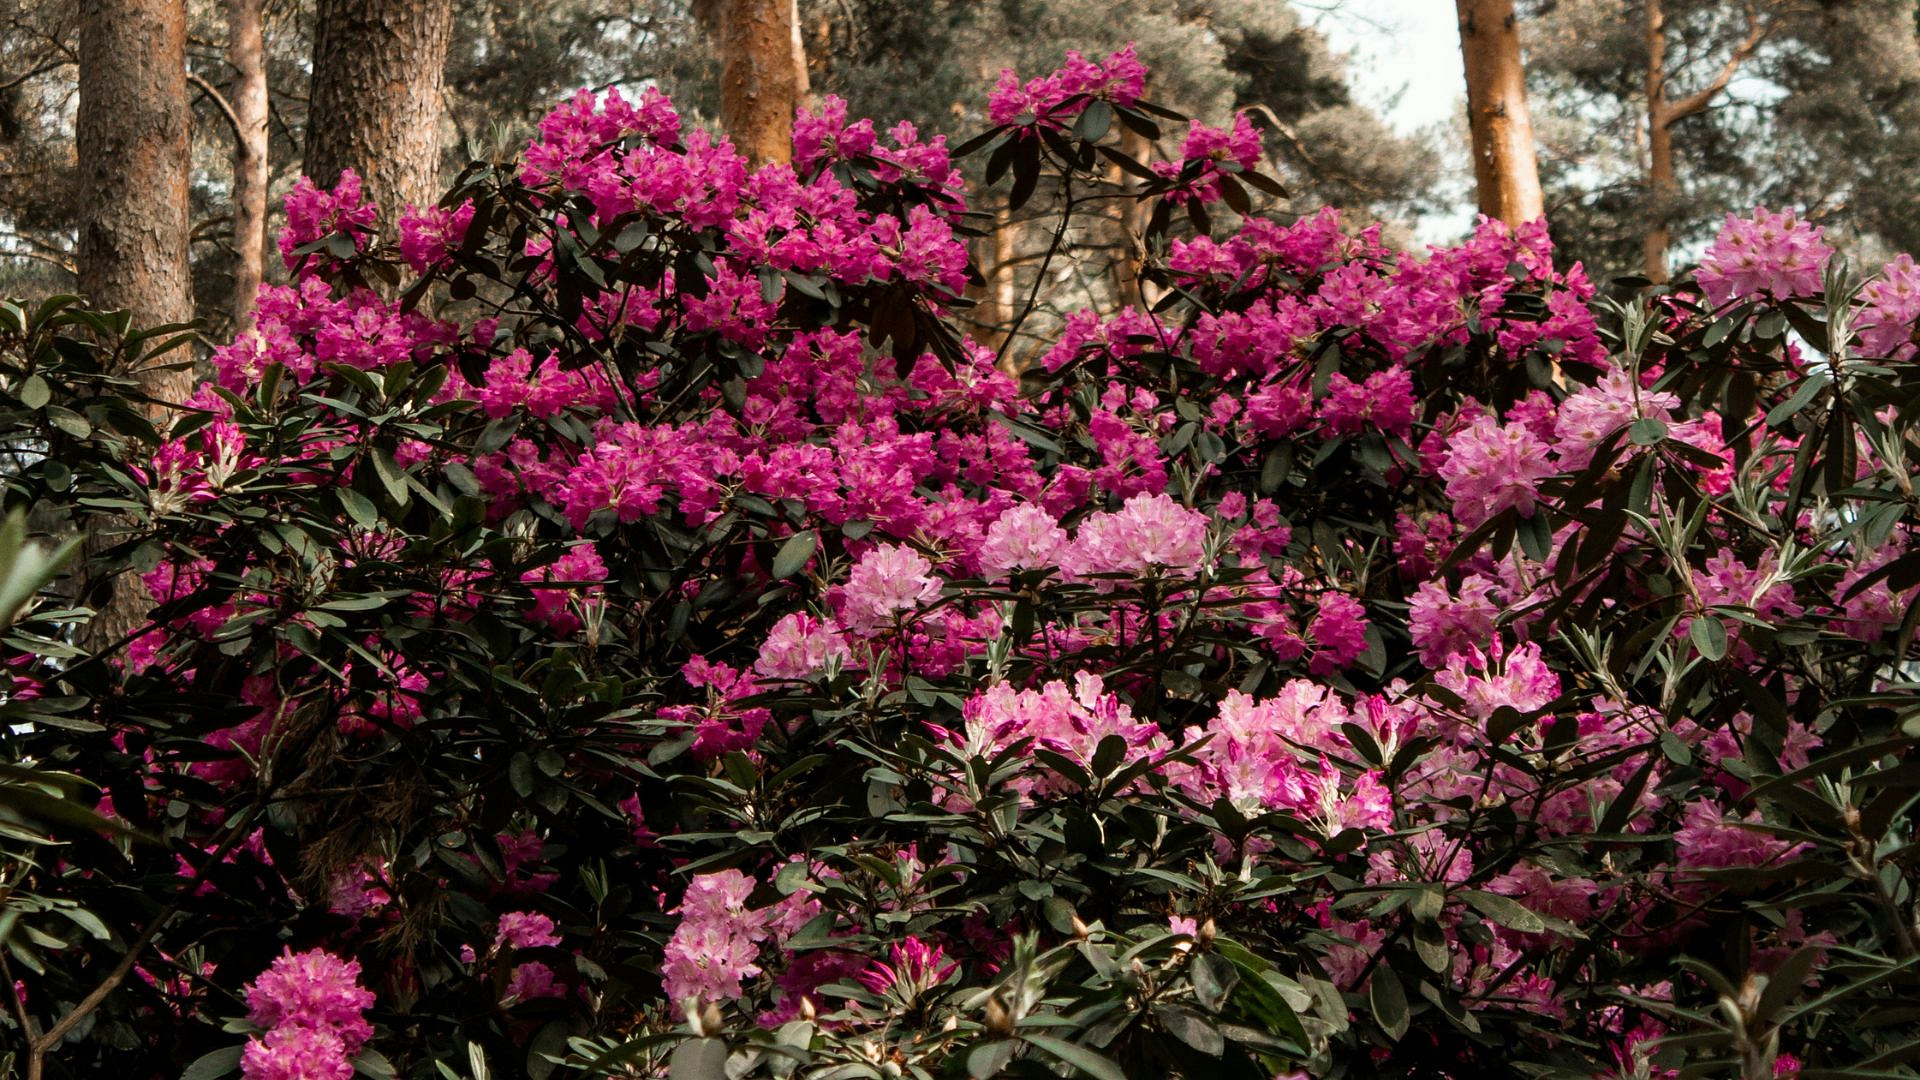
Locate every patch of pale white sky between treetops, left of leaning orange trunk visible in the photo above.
<box><xmin>1292</xmin><ymin>0</ymin><xmax>1473</xmax><ymax>244</ymax></box>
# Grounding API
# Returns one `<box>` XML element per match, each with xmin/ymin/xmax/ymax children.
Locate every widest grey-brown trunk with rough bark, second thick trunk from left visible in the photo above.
<box><xmin>303</xmin><ymin>0</ymin><xmax>453</xmax><ymax>215</ymax></box>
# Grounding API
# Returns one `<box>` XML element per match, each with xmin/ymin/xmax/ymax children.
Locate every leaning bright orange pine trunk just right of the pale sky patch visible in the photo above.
<box><xmin>1455</xmin><ymin>0</ymin><xmax>1546</xmax><ymax>225</ymax></box>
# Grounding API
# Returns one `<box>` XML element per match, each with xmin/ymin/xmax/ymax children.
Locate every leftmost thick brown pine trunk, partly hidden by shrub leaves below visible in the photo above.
<box><xmin>75</xmin><ymin>0</ymin><xmax>194</xmax><ymax>645</ymax></box>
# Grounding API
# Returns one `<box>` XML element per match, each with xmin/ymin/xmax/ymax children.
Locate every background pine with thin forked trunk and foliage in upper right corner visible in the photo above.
<box><xmin>1521</xmin><ymin>0</ymin><xmax>1920</xmax><ymax>277</ymax></box>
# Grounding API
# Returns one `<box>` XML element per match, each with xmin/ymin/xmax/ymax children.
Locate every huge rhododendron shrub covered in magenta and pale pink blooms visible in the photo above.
<box><xmin>0</xmin><ymin>52</ymin><xmax>1920</xmax><ymax>1080</ymax></box>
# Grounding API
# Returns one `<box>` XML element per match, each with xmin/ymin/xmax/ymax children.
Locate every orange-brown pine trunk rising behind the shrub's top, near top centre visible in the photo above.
<box><xmin>718</xmin><ymin>0</ymin><xmax>806</xmax><ymax>165</ymax></box>
